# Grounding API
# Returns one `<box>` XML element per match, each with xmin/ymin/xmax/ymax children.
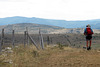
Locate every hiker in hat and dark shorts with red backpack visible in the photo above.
<box><xmin>84</xmin><ymin>24</ymin><xmax>94</xmax><ymax>50</ymax></box>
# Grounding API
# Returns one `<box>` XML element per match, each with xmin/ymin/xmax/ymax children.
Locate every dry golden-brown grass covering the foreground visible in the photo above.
<box><xmin>0</xmin><ymin>46</ymin><xmax>100</xmax><ymax>67</ymax></box>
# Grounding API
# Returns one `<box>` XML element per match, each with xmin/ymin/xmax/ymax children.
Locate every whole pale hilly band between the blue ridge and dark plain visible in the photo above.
<box><xmin>0</xmin><ymin>23</ymin><xmax>100</xmax><ymax>34</ymax></box>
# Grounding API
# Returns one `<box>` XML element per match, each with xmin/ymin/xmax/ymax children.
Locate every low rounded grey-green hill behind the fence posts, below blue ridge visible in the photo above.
<box><xmin>0</xmin><ymin>23</ymin><xmax>64</xmax><ymax>34</ymax></box>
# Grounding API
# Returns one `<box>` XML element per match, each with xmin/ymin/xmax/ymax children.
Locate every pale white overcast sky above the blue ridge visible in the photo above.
<box><xmin>0</xmin><ymin>0</ymin><xmax>100</xmax><ymax>20</ymax></box>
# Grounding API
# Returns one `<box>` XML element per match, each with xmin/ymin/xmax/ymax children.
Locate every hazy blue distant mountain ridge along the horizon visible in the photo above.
<box><xmin>0</xmin><ymin>16</ymin><xmax>100</xmax><ymax>29</ymax></box>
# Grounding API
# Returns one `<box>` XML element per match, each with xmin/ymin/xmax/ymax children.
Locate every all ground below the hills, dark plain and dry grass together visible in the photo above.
<box><xmin>0</xmin><ymin>34</ymin><xmax>100</xmax><ymax>67</ymax></box>
